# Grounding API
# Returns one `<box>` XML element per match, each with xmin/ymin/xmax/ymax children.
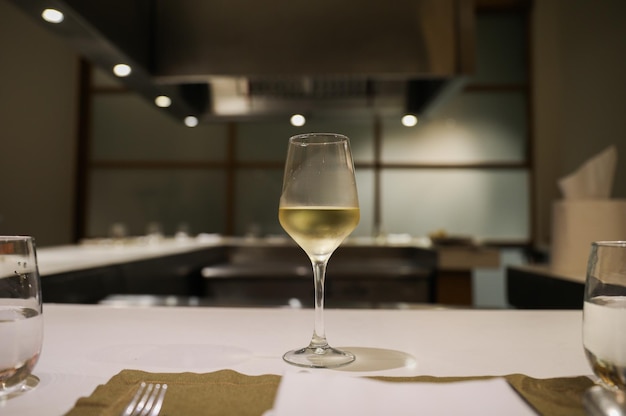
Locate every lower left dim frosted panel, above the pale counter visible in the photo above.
<box><xmin>87</xmin><ymin>169</ymin><xmax>226</xmax><ymax>237</ymax></box>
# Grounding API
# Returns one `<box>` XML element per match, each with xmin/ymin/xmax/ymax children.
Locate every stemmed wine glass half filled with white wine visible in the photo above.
<box><xmin>278</xmin><ymin>133</ymin><xmax>360</xmax><ymax>368</ymax></box>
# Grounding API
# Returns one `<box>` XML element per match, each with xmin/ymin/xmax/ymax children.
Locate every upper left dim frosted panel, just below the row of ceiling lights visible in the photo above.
<box><xmin>92</xmin><ymin>93</ymin><xmax>227</xmax><ymax>162</ymax></box>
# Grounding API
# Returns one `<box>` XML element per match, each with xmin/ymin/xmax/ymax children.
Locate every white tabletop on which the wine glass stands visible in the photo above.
<box><xmin>0</xmin><ymin>303</ymin><xmax>591</xmax><ymax>416</ymax></box>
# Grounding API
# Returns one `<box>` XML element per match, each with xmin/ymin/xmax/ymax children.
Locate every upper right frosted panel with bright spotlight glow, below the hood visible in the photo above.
<box><xmin>382</xmin><ymin>92</ymin><xmax>528</xmax><ymax>164</ymax></box>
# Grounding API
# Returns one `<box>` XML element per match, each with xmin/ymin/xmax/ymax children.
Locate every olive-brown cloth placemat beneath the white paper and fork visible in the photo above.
<box><xmin>66</xmin><ymin>370</ymin><xmax>593</xmax><ymax>416</ymax></box>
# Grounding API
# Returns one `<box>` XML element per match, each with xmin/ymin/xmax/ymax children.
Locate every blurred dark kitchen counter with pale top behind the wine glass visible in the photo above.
<box><xmin>38</xmin><ymin>235</ymin><xmax>499</xmax><ymax>305</ymax></box>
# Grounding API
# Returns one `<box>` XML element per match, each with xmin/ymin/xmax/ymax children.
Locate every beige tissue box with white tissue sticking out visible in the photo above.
<box><xmin>550</xmin><ymin>146</ymin><xmax>626</xmax><ymax>281</ymax></box>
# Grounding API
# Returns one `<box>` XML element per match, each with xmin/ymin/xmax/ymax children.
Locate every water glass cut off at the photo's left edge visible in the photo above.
<box><xmin>0</xmin><ymin>236</ymin><xmax>43</xmax><ymax>398</ymax></box>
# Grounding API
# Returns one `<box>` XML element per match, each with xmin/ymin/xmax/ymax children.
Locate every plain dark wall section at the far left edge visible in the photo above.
<box><xmin>0</xmin><ymin>0</ymin><xmax>78</xmax><ymax>246</ymax></box>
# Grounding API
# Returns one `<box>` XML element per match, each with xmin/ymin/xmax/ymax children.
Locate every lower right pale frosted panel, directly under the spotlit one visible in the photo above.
<box><xmin>381</xmin><ymin>169</ymin><xmax>529</xmax><ymax>240</ymax></box>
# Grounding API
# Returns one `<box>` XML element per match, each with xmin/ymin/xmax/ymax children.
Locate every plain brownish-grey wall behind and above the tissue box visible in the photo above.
<box><xmin>533</xmin><ymin>0</ymin><xmax>626</xmax><ymax>243</ymax></box>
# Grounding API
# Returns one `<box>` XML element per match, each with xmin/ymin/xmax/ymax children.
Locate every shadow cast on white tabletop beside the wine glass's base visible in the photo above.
<box><xmin>337</xmin><ymin>347</ymin><xmax>417</xmax><ymax>372</ymax></box>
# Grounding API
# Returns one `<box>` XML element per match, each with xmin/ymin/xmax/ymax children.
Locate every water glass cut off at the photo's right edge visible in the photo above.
<box><xmin>583</xmin><ymin>241</ymin><xmax>626</xmax><ymax>409</ymax></box>
